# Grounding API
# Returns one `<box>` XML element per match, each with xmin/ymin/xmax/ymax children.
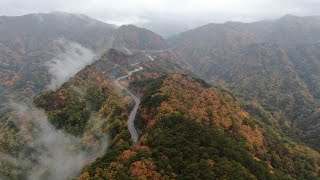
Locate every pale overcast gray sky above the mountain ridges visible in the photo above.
<box><xmin>0</xmin><ymin>0</ymin><xmax>320</xmax><ymax>24</ymax></box>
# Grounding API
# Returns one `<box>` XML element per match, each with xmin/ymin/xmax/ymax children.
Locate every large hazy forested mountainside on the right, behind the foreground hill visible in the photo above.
<box><xmin>169</xmin><ymin>15</ymin><xmax>320</xmax><ymax>149</ymax></box>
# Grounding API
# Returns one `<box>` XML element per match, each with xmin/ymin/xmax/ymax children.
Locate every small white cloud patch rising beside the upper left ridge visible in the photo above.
<box><xmin>47</xmin><ymin>39</ymin><xmax>95</xmax><ymax>90</ymax></box>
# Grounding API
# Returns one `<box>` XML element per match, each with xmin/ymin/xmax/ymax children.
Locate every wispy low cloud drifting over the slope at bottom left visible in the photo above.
<box><xmin>11</xmin><ymin>103</ymin><xmax>107</xmax><ymax>180</ymax></box>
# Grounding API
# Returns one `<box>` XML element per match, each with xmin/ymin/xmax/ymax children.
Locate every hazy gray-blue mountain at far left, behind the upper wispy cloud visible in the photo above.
<box><xmin>0</xmin><ymin>12</ymin><xmax>116</xmax><ymax>67</ymax></box>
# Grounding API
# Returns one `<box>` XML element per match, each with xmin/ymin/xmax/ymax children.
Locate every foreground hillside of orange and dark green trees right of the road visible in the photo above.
<box><xmin>80</xmin><ymin>74</ymin><xmax>319</xmax><ymax>179</ymax></box>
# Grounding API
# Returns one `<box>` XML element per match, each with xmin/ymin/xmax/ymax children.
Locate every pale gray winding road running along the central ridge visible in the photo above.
<box><xmin>114</xmin><ymin>69</ymin><xmax>141</xmax><ymax>142</ymax></box>
